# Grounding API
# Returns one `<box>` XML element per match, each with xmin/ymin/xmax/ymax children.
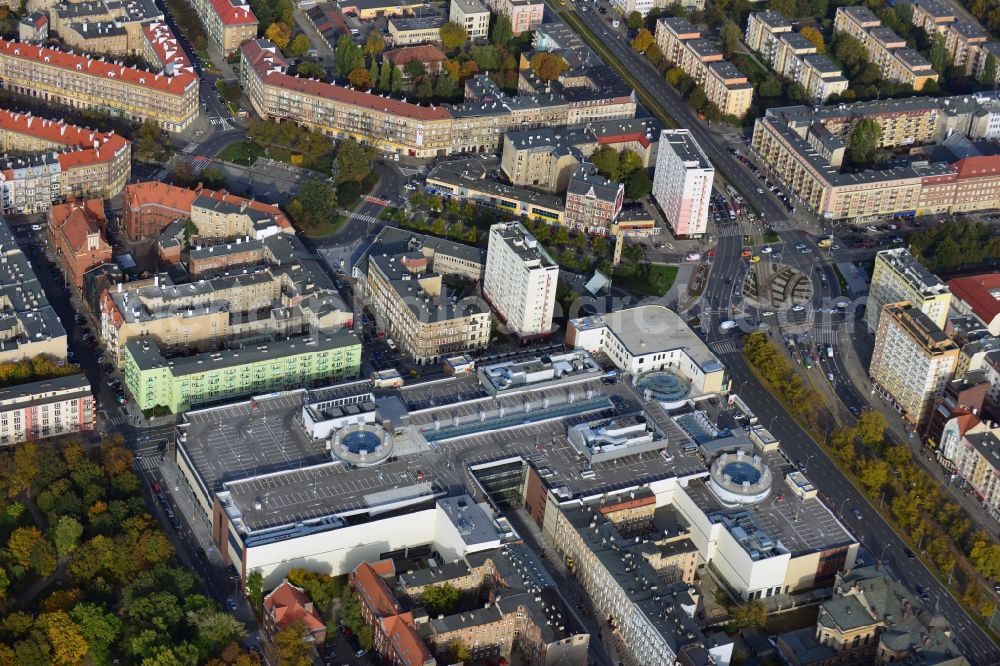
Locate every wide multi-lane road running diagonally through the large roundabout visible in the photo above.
<box><xmin>552</xmin><ymin>0</ymin><xmax>1000</xmax><ymax>665</ymax></box>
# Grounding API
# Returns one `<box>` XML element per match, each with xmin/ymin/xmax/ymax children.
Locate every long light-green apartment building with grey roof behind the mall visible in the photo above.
<box><xmin>122</xmin><ymin>329</ymin><xmax>361</xmax><ymax>414</ymax></box>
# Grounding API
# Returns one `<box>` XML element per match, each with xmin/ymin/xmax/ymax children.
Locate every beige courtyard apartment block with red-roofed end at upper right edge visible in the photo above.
<box><xmin>752</xmin><ymin>96</ymin><xmax>1000</xmax><ymax>224</ymax></box>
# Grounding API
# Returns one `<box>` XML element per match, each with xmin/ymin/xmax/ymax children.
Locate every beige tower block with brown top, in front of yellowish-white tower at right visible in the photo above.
<box><xmin>868</xmin><ymin>301</ymin><xmax>958</xmax><ymax>427</ymax></box>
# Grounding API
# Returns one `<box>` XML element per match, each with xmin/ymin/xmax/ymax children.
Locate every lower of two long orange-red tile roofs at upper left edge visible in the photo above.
<box><xmin>0</xmin><ymin>109</ymin><xmax>130</xmax><ymax>169</ymax></box>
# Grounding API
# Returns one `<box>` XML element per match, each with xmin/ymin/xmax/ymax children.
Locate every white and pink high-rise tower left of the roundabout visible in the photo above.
<box><xmin>653</xmin><ymin>129</ymin><xmax>715</xmax><ymax>238</ymax></box>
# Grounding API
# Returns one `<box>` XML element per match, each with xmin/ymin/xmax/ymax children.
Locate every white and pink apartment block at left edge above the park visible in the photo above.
<box><xmin>0</xmin><ymin>374</ymin><xmax>97</xmax><ymax>446</ymax></box>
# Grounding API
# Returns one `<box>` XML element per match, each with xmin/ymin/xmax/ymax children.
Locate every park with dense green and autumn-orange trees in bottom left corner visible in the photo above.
<box><xmin>0</xmin><ymin>436</ymin><xmax>257</xmax><ymax>666</ymax></box>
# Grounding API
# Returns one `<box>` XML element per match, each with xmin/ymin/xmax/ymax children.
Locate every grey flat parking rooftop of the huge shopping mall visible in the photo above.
<box><xmin>177</xmin><ymin>350</ymin><xmax>844</xmax><ymax>550</ymax></box>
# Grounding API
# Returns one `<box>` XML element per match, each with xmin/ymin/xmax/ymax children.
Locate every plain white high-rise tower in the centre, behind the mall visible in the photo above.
<box><xmin>483</xmin><ymin>222</ymin><xmax>559</xmax><ymax>339</ymax></box>
